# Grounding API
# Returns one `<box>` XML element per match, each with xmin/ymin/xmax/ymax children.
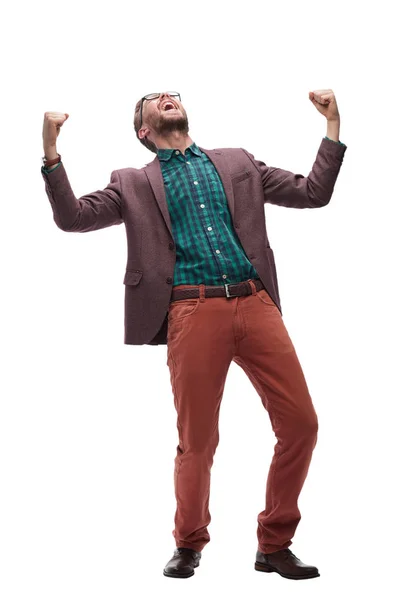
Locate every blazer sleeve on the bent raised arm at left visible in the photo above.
<box><xmin>41</xmin><ymin>162</ymin><xmax>124</xmax><ymax>233</ymax></box>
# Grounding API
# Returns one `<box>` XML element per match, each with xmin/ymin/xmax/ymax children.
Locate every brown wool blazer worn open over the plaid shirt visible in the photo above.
<box><xmin>41</xmin><ymin>138</ymin><xmax>347</xmax><ymax>345</ymax></box>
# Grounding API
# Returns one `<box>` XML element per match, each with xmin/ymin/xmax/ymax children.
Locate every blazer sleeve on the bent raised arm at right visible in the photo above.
<box><xmin>241</xmin><ymin>138</ymin><xmax>347</xmax><ymax>208</ymax></box>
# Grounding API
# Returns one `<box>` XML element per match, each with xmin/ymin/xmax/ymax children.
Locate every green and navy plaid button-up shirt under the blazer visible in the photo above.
<box><xmin>42</xmin><ymin>136</ymin><xmax>341</xmax><ymax>285</ymax></box>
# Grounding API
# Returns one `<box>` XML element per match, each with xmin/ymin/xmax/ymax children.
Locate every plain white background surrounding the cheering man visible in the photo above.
<box><xmin>0</xmin><ymin>0</ymin><xmax>400</xmax><ymax>600</ymax></box>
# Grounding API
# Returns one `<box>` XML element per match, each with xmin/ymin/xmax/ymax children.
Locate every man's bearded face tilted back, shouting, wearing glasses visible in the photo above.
<box><xmin>140</xmin><ymin>92</ymin><xmax>189</xmax><ymax>137</ymax></box>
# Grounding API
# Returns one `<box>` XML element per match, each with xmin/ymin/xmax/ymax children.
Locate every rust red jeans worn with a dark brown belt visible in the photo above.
<box><xmin>167</xmin><ymin>280</ymin><xmax>318</xmax><ymax>553</ymax></box>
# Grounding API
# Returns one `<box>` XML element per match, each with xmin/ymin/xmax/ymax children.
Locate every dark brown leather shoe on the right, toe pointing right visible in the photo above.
<box><xmin>254</xmin><ymin>548</ymin><xmax>320</xmax><ymax>579</ymax></box>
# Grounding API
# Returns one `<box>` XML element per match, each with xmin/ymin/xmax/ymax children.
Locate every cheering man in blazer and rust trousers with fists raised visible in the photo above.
<box><xmin>42</xmin><ymin>90</ymin><xmax>347</xmax><ymax>579</ymax></box>
